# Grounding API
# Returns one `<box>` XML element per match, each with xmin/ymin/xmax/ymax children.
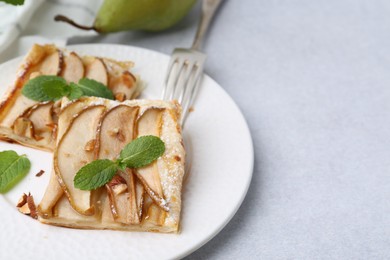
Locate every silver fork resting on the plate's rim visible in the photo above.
<box><xmin>162</xmin><ymin>0</ymin><xmax>222</xmax><ymax>127</ymax></box>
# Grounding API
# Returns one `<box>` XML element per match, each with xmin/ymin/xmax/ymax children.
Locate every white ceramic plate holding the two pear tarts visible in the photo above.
<box><xmin>0</xmin><ymin>44</ymin><xmax>253</xmax><ymax>260</ymax></box>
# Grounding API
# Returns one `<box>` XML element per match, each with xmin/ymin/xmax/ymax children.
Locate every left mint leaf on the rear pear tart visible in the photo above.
<box><xmin>22</xmin><ymin>75</ymin><xmax>69</xmax><ymax>101</ymax></box>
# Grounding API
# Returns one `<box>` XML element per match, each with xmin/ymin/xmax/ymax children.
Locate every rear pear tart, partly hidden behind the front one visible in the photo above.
<box><xmin>0</xmin><ymin>45</ymin><xmax>141</xmax><ymax>151</ymax></box>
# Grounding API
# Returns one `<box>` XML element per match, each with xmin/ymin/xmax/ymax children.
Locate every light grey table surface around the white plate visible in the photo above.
<box><xmin>6</xmin><ymin>0</ymin><xmax>390</xmax><ymax>259</ymax></box>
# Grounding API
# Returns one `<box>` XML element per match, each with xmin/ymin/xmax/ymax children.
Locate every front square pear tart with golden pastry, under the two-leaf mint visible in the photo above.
<box><xmin>38</xmin><ymin>97</ymin><xmax>185</xmax><ymax>233</ymax></box>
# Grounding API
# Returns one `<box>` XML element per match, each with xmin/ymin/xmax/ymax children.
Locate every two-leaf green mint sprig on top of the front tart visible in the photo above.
<box><xmin>73</xmin><ymin>135</ymin><xmax>165</xmax><ymax>190</ymax></box>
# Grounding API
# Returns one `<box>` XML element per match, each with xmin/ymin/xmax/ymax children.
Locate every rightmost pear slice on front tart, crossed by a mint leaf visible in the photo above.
<box><xmin>135</xmin><ymin>108</ymin><xmax>169</xmax><ymax>211</ymax></box>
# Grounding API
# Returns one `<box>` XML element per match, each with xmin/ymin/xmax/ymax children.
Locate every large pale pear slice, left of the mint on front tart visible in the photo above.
<box><xmin>54</xmin><ymin>105</ymin><xmax>105</xmax><ymax>215</ymax></box>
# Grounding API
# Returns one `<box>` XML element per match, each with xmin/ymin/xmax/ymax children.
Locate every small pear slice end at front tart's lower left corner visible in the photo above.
<box><xmin>38</xmin><ymin>171</ymin><xmax>64</xmax><ymax>218</ymax></box>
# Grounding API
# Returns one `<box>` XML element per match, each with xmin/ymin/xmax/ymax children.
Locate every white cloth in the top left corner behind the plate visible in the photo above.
<box><xmin>0</xmin><ymin>0</ymin><xmax>103</xmax><ymax>63</ymax></box>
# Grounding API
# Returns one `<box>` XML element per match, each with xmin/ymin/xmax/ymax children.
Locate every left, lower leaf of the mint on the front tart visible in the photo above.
<box><xmin>73</xmin><ymin>159</ymin><xmax>118</xmax><ymax>190</ymax></box>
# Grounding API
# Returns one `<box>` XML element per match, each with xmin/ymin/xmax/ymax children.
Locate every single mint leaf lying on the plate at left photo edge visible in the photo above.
<box><xmin>0</xmin><ymin>151</ymin><xmax>31</xmax><ymax>193</ymax></box>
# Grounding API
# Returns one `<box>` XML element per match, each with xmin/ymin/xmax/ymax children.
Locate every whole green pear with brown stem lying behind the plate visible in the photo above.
<box><xmin>55</xmin><ymin>0</ymin><xmax>196</xmax><ymax>33</ymax></box>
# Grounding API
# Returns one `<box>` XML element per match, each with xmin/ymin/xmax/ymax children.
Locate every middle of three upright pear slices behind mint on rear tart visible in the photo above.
<box><xmin>61</xmin><ymin>52</ymin><xmax>84</xmax><ymax>82</ymax></box>
